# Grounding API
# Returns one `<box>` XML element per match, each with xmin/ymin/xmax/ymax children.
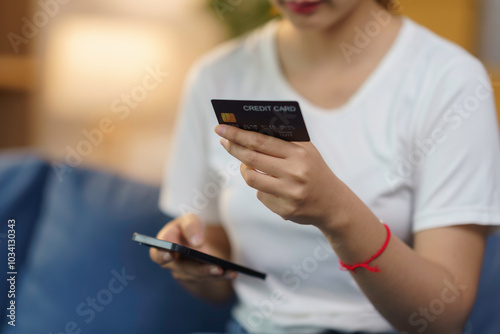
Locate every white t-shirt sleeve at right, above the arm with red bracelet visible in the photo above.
<box><xmin>409</xmin><ymin>58</ymin><xmax>500</xmax><ymax>232</ymax></box>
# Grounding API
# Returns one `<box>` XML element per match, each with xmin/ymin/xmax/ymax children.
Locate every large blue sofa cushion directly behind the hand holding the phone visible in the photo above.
<box><xmin>1</xmin><ymin>160</ymin><xmax>228</xmax><ymax>334</ymax></box>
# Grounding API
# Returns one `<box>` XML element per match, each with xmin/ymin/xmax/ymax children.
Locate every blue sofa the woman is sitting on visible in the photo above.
<box><xmin>0</xmin><ymin>152</ymin><xmax>500</xmax><ymax>334</ymax></box>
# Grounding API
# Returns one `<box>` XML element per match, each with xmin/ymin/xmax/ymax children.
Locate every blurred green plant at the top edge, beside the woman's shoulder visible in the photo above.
<box><xmin>208</xmin><ymin>0</ymin><xmax>279</xmax><ymax>37</ymax></box>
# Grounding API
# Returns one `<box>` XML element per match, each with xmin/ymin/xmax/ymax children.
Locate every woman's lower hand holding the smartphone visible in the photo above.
<box><xmin>149</xmin><ymin>214</ymin><xmax>236</xmax><ymax>283</ymax></box>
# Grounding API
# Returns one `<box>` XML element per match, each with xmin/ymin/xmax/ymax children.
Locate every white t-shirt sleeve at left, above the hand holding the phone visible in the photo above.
<box><xmin>159</xmin><ymin>65</ymin><xmax>219</xmax><ymax>224</ymax></box>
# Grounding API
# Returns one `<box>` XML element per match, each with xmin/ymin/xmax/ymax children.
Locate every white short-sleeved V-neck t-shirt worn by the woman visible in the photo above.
<box><xmin>160</xmin><ymin>18</ymin><xmax>500</xmax><ymax>334</ymax></box>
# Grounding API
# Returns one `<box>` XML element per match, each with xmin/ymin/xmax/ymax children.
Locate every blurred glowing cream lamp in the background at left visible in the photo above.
<box><xmin>41</xmin><ymin>16</ymin><xmax>175</xmax><ymax>117</ymax></box>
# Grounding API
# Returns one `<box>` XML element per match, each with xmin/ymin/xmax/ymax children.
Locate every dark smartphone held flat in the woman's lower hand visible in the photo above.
<box><xmin>132</xmin><ymin>233</ymin><xmax>266</xmax><ymax>280</ymax></box>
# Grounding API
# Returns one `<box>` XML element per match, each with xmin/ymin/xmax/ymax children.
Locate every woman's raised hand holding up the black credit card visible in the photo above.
<box><xmin>215</xmin><ymin>125</ymin><xmax>355</xmax><ymax>229</ymax></box>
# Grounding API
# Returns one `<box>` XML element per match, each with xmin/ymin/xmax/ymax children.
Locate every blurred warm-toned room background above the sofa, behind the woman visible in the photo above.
<box><xmin>0</xmin><ymin>0</ymin><xmax>500</xmax><ymax>184</ymax></box>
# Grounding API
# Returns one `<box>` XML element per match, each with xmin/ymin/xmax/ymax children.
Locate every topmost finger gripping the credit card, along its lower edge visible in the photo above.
<box><xmin>215</xmin><ymin>125</ymin><xmax>292</xmax><ymax>158</ymax></box>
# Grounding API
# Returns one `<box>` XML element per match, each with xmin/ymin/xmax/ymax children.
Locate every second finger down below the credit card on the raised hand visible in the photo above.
<box><xmin>221</xmin><ymin>139</ymin><xmax>283</xmax><ymax>177</ymax></box>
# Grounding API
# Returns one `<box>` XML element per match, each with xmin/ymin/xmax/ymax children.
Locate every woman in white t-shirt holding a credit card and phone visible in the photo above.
<box><xmin>151</xmin><ymin>0</ymin><xmax>500</xmax><ymax>334</ymax></box>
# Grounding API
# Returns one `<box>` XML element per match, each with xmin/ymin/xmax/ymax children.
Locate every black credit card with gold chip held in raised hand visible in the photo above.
<box><xmin>212</xmin><ymin>99</ymin><xmax>310</xmax><ymax>141</ymax></box>
